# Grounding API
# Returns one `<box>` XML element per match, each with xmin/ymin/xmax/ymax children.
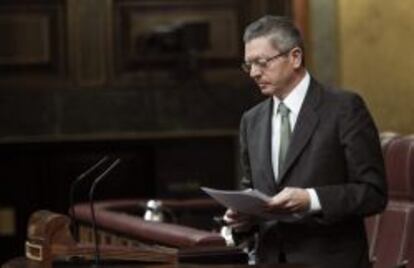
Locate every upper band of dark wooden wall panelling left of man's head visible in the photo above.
<box><xmin>0</xmin><ymin>0</ymin><xmax>290</xmax><ymax>89</ymax></box>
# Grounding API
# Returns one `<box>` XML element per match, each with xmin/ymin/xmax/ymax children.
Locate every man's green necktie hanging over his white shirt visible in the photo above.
<box><xmin>277</xmin><ymin>102</ymin><xmax>291</xmax><ymax>175</ymax></box>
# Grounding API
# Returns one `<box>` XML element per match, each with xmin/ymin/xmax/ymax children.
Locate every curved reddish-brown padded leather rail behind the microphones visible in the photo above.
<box><xmin>73</xmin><ymin>199</ymin><xmax>247</xmax><ymax>264</ymax></box>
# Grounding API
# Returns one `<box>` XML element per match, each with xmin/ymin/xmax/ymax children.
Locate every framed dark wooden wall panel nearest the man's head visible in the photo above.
<box><xmin>113</xmin><ymin>0</ymin><xmax>247</xmax><ymax>85</ymax></box>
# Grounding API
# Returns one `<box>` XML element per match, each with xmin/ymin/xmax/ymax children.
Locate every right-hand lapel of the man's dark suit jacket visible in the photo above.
<box><xmin>279</xmin><ymin>79</ymin><xmax>321</xmax><ymax>183</ymax></box>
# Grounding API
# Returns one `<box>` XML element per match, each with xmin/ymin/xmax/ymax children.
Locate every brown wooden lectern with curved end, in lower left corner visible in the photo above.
<box><xmin>25</xmin><ymin>210</ymin><xmax>177</xmax><ymax>267</ymax></box>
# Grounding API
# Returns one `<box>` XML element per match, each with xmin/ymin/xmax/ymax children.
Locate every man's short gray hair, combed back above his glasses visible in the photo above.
<box><xmin>243</xmin><ymin>15</ymin><xmax>304</xmax><ymax>53</ymax></box>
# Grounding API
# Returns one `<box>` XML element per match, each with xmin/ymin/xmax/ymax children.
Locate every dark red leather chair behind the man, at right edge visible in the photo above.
<box><xmin>365</xmin><ymin>136</ymin><xmax>414</xmax><ymax>268</ymax></box>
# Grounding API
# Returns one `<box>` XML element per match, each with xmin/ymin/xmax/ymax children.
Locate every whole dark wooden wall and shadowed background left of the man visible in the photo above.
<box><xmin>0</xmin><ymin>0</ymin><xmax>292</xmax><ymax>263</ymax></box>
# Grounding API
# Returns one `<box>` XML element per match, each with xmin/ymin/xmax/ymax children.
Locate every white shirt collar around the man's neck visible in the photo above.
<box><xmin>273</xmin><ymin>71</ymin><xmax>310</xmax><ymax>115</ymax></box>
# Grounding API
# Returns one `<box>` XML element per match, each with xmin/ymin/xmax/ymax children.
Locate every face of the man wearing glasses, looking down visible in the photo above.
<box><xmin>244</xmin><ymin>37</ymin><xmax>302</xmax><ymax>98</ymax></box>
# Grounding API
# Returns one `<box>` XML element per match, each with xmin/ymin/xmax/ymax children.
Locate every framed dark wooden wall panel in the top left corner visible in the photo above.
<box><xmin>0</xmin><ymin>0</ymin><xmax>67</xmax><ymax>87</ymax></box>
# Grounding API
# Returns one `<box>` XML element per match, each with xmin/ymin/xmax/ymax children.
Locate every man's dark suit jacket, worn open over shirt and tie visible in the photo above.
<box><xmin>240</xmin><ymin>79</ymin><xmax>387</xmax><ymax>268</ymax></box>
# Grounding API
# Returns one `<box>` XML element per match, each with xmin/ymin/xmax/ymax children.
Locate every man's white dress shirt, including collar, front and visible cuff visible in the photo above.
<box><xmin>272</xmin><ymin>72</ymin><xmax>321</xmax><ymax>212</ymax></box>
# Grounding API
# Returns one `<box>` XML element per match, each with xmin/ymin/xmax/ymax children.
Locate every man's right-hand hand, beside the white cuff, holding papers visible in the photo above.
<box><xmin>266</xmin><ymin>187</ymin><xmax>310</xmax><ymax>214</ymax></box>
